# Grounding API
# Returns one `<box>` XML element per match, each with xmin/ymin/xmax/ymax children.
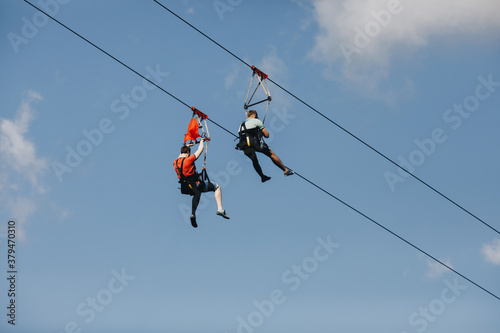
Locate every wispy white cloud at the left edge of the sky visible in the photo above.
<box><xmin>0</xmin><ymin>91</ymin><xmax>47</xmax><ymax>188</ymax></box>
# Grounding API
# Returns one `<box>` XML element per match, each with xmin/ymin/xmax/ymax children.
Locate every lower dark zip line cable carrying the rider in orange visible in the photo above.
<box><xmin>24</xmin><ymin>0</ymin><xmax>500</xmax><ymax>300</ymax></box>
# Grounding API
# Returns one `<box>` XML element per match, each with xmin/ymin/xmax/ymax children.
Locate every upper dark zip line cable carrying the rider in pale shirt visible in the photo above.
<box><xmin>153</xmin><ymin>0</ymin><xmax>500</xmax><ymax>235</ymax></box>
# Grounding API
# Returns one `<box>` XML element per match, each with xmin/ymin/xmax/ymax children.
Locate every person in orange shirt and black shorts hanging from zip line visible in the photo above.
<box><xmin>174</xmin><ymin>139</ymin><xmax>229</xmax><ymax>228</ymax></box>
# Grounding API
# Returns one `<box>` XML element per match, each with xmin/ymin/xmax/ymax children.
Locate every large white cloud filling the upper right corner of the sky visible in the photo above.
<box><xmin>309</xmin><ymin>0</ymin><xmax>500</xmax><ymax>98</ymax></box>
